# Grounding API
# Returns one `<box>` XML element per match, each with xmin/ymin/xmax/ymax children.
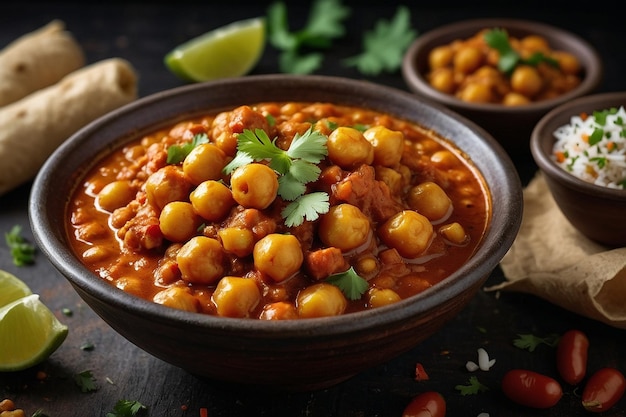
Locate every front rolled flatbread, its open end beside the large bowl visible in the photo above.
<box><xmin>0</xmin><ymin>58</ymin><xmax>137</xmax><ymax>195</ymax></box>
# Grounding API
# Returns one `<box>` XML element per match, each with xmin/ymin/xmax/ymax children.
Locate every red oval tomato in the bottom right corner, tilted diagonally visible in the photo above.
<box><xmin>582</xmin><ymin>368</ymin><xmax>626</xmax><ymax>413</ymax></box>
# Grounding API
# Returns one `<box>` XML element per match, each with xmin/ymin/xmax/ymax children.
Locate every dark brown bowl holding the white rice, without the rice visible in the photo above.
<box><xmin>530</xmin><ymin>91</ymin><xmax>626</xmax><ymax>246</ymax></box>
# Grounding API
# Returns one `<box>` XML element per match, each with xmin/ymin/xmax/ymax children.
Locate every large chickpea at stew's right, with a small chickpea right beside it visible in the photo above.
<box><xmin>378</xmin><ymin>210</ymin><xmax>433</xmax><ymax>259</ymax></box>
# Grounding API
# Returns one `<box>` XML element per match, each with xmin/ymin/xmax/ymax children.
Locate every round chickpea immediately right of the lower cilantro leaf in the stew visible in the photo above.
<box><xmin>318</xmin><ymin>203</ymin><xmax>371</xmax><ymax>252</ymax></box>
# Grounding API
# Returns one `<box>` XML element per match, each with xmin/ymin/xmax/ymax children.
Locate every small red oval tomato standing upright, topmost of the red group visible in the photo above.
<box><xmin>556</xmin><ymin>330</ymin><xmax>589</xmax><ymax>385</ymax></box>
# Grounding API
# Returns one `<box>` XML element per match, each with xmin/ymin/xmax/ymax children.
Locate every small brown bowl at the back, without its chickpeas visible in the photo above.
<box><xmin>402</xmin><ymin>19</ymin><xmax>603</xmax><ymax>156</ymax></box>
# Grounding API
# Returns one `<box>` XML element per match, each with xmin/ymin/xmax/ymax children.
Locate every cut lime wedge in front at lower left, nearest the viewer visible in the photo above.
<box><xmin>0</xmin><ymin>294</ymin><xmax>68</xmax><ymax>372</ymax></box>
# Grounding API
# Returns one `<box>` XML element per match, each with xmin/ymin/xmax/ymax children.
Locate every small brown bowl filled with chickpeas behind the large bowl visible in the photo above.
<box><xmin>402</xmin><ymin>18</ymin><xmax>603</xmax><ymax>159</ymax></box>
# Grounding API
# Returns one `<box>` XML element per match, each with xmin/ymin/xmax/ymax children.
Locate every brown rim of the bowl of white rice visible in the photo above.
<box><xmin>530</xmin><ymin>91</ymin><xmax>626</xmax><ymax>201</ymax></box>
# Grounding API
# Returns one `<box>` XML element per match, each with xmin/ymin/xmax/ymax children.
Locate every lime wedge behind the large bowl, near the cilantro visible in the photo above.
<box><xmin>165</xmin><ymin>17</ymin><xmax>265</xmax><ymax>82</ymax></box>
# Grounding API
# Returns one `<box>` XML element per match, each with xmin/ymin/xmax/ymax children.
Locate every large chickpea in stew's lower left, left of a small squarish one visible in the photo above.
<box><xmin>176</xmin><ymin>236</ymin><xmax>224</xmax><ymax>285</ymax></box>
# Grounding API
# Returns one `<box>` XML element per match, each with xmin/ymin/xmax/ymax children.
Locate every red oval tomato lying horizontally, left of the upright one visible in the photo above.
<box><xmin>502</xmin><ymin>369</ymin><xmax>563</xmax><ymax>408</ymax></box>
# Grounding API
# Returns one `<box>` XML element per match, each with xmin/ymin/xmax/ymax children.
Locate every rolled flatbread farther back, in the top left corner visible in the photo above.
<box><xmin>0</xmin><ymin>20</ymin><xmax>85</xmax><ymax>106</ymax></box>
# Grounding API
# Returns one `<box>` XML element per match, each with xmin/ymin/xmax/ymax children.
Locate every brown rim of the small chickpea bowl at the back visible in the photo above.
<box><xmin>402</xmin><ymin>18</ymin><xmax>604</xmax><ymax>113</ymax></box>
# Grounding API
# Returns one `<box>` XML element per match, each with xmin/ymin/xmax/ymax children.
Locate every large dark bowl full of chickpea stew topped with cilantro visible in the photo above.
<box><xmin>29</xmin><ymin>75</ymin><xmax>522</xmax><ymax>391</ymax></box>
